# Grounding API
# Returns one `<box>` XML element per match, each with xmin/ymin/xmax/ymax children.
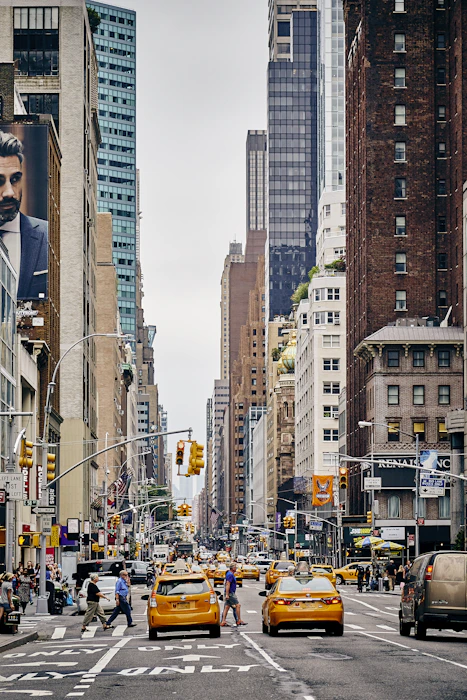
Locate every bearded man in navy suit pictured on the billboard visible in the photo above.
<box><xmin>0</xmin><ymin>131</ymin><xmax>48</xmax><ymax>299</ymax></box>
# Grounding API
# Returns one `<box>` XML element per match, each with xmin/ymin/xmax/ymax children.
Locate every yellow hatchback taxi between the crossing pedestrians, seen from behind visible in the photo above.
<box><xmin>147</xmin><ymin>572</ymin><xmax>221</xmax><ymax>639</ymax></box>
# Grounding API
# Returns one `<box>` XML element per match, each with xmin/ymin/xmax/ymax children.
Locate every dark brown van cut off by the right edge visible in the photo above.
<box><xmin>399</xmin><ymin>551</ymin><xmax>467</xmax><ymax>639</ymax></box>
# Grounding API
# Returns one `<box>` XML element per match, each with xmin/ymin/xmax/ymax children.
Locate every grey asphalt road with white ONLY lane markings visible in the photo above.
<box><xmin>0</xmin><ymin>582</ymin><xmax>467</xmax><ymax>700</ymax></box>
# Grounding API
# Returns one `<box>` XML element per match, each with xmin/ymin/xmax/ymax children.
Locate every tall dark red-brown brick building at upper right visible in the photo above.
<box><xmin>344</xmin><ymin>0</ymin><xmax>467</xmax><ymax>512</ymax></box>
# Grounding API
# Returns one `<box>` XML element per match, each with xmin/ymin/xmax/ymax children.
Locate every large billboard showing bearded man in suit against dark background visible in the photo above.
<box><xmin>0</xmin><ymin>123</ymin><xmax>49</xmax><ymax>301</ymax></box>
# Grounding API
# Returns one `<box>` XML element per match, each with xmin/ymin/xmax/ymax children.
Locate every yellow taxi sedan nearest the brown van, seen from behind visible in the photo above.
<box><xmin>259</xmin><ymin>574</ymin><xmax>344</xmax><ymax>637</ymax></box>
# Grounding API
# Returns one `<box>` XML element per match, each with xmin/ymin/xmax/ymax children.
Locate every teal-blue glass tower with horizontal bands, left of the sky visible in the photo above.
<box><xmin>87</xmin><ymin>2</ymin><xmax>138</xmax><ymax>335</ymax></box>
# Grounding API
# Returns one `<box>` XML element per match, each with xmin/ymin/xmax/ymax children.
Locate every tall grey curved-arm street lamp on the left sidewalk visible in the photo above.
<box><xmin>36</xmin><ymin>333</ymin><xmax>129</xmax><ymax>615</ymax></box>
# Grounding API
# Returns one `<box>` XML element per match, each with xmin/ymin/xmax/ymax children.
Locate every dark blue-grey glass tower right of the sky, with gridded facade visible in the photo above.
<box><xmin>266</xmin><ymin>9</ymin><xmax>318</xmax><ymax>320</ymax></box>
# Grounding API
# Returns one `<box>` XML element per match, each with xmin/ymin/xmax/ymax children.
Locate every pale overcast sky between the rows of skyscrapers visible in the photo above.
<box><xmin>105</xmin><ymin>0</ymin><xmax>268</xmax><ymax>493</ymax></box>
